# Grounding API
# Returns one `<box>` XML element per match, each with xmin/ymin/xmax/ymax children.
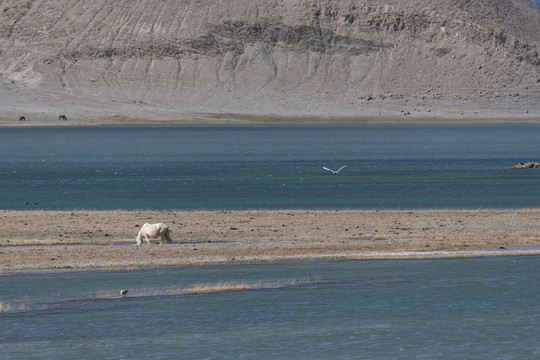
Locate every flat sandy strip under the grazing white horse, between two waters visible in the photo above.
<box><xmin>0</xmin><ymin>209</ymin><xmax>540</xmax><ymax>272</ymax></box>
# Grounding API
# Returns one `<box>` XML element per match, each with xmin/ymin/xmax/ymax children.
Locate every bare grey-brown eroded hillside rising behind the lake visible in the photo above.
<box><xmin>0</xmin><ymin>0</ymin><xmax>540</xmax><ymax>116</ymax></box>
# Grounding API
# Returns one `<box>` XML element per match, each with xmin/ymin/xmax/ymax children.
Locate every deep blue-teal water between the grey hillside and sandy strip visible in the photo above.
<box><xmin>0</xmin><ymin>124</ymin><xmax>540</xmax><ymax>210</ymax></box>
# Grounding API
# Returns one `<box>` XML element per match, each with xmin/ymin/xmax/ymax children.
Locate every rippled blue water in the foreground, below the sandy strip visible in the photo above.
<box><xmin>0</xmin><ymin>257</ymin><xmax>540</xmax><ymax>359</ymax></box>
